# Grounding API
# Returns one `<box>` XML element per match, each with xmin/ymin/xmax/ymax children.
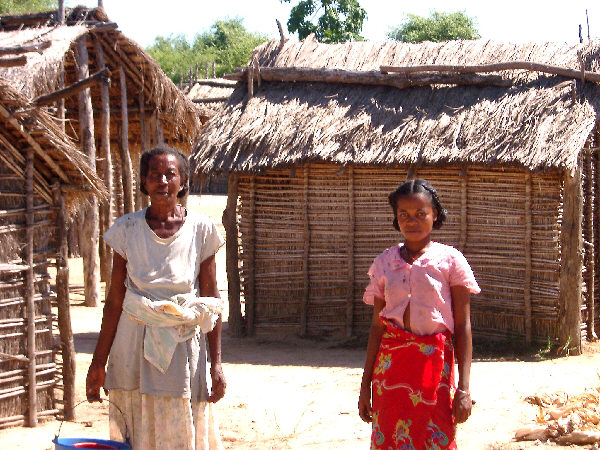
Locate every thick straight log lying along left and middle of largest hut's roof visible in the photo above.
<box><xmin>223</xmin><ymin>65</ymin><xmax>512</xmax><ymax>89</ymax></box>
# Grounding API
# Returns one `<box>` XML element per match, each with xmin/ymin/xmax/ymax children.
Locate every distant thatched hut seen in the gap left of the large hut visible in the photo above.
<box><xmin>186</xmin><ymin>78</ymin><xmax>238</xmax><ymax>194</ymax></box>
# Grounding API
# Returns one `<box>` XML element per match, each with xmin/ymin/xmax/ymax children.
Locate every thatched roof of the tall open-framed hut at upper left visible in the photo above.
<box><xmin>0</xmin><ymin>7</ymin><xmax>208</xmax><ymax>151</ymax></box>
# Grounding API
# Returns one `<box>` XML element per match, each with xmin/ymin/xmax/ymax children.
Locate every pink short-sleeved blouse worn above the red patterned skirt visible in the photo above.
<box><xmin>363</xmin><ymin>242</ymin><xmax>481</xmax><ymax>336</ymax></box>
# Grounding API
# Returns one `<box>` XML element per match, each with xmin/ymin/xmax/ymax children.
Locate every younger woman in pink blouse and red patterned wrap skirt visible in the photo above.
<box><xmin>358</xmin><ymin>178</ymin><xmax>480</xmax><ymax>449</ymax></box>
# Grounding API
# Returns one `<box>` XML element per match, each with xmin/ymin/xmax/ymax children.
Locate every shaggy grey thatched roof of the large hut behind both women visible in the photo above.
<box><xmin>194</xmin><ymin>38</ymin><xmax>600</xmax><ymax>172</ymax></box>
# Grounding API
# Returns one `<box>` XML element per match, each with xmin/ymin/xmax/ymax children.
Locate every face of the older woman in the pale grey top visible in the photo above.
<box><xmin>142</xmin><ymin>154</ymin><xmax>183</xmax><ymax>204</ymax></box>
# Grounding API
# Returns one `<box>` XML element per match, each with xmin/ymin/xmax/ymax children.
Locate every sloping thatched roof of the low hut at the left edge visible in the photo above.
<box><xmin>0</xmin><ymin>78</ymin><xmax>107</xmax><ymax>204</ymax></box>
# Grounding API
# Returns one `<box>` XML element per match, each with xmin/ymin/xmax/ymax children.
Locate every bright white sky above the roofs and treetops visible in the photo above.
<box><xmin>65</xmin><ymin>0</ymin><xmax>600</xmax><ymax>47</ymax></box>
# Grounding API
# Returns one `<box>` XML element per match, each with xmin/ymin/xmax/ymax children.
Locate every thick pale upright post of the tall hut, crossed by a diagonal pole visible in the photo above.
<box><xmin>77</xmin><ymin>35</ymin><xmax>100</xmax><ymax>306</ymax></box>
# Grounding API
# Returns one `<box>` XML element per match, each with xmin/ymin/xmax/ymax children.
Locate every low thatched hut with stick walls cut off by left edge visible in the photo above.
<box><xmin>0</xmin><ymin>78</ymin><xmax>106</xmax><ymax>428</ymax></box>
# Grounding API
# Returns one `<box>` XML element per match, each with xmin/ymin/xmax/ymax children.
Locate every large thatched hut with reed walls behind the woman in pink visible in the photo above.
<box><xmin>194</xmin><ymin>38</ymin><xmax>600</xmax><ymax>351</ymax></box>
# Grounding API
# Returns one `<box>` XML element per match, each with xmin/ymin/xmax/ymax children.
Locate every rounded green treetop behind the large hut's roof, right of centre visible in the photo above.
<box><xmin>387</xmin><ymin>11</ymin><xmax>481</xmax><ymax>42</ymax></box>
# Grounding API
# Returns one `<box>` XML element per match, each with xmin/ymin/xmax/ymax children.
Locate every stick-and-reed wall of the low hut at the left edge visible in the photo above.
<box><xmin>0</xmin><ymin>165</ymin><xmax>58</xmax><ymax>428</ymax></box>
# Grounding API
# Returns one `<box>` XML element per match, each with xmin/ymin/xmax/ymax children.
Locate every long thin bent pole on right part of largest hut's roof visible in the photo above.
<box><xmin>380</xmin><ymin>61</ymin><xmax>600</xmax><ymax>83</ymax></box>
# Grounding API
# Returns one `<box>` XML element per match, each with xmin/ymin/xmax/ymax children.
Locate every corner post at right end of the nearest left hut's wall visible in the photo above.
<box><xmin>52</xmin><ymin>182</ymin><xmax>76</xmax><ymax>420</ymax></box>
